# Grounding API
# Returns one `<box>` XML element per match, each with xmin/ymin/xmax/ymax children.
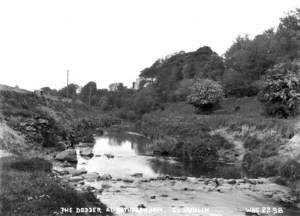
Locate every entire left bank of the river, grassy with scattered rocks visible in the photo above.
<box><xmin>0</xmin><ymin>91</ymin><xmax>118</xmax><ymax>216</ymax></box>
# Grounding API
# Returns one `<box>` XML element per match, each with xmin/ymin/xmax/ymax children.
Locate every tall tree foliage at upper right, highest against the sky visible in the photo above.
<box><xmin>225</xmin><ymin>9</ymin><xmax>300</xmax><ymax>82</ymax></box>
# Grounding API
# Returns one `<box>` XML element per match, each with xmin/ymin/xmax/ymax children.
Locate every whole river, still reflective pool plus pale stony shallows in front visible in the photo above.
<box><xmin>77</xmin><ymin>132</ymin><xmax>300</xmax><ymax>216</ymax></box>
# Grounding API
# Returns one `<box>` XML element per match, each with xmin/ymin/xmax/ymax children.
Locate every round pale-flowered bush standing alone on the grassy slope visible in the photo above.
<box><xmin>187</xmin><ymin>79</ymin><xmax>224</xmax><ymax>113</ymax></box>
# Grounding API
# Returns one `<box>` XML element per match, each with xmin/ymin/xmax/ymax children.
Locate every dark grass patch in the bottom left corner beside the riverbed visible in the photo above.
<box><xmin>0</xmin><ymin>157</ymin><xmax>110</xmax><ymax>216</ymax></box>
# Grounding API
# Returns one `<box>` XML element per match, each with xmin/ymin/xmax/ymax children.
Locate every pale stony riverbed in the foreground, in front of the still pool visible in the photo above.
<box><xmin>53</xmin><ymin>150</ymin><xmax>297</xmax><ymax>216</ymax></box>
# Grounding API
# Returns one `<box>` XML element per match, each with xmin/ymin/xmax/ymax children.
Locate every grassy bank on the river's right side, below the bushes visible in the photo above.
<box><xmin>137</xmin><ymin>97</ymin><xmax>300</xmax><ymax>192</ymax></box>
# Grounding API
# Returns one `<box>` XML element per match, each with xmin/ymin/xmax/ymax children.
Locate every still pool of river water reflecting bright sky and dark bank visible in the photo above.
<box><xmin>78</xmin><ymin>132</ymin><xmax>241</xmax><ymax>178</ymax></box>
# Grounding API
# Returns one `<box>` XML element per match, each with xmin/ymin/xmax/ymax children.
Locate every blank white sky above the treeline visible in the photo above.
<box><xmin>0</xmin><ymin>0</ymin><xmax>300</xmax><ymax>90</ymax></box>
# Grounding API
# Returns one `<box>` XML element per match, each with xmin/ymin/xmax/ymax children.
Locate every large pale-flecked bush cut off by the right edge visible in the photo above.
<box><xmin>259</xmin><ymin>64</ymin><xmax>300</xmax><ymax>118</ymax></box>
